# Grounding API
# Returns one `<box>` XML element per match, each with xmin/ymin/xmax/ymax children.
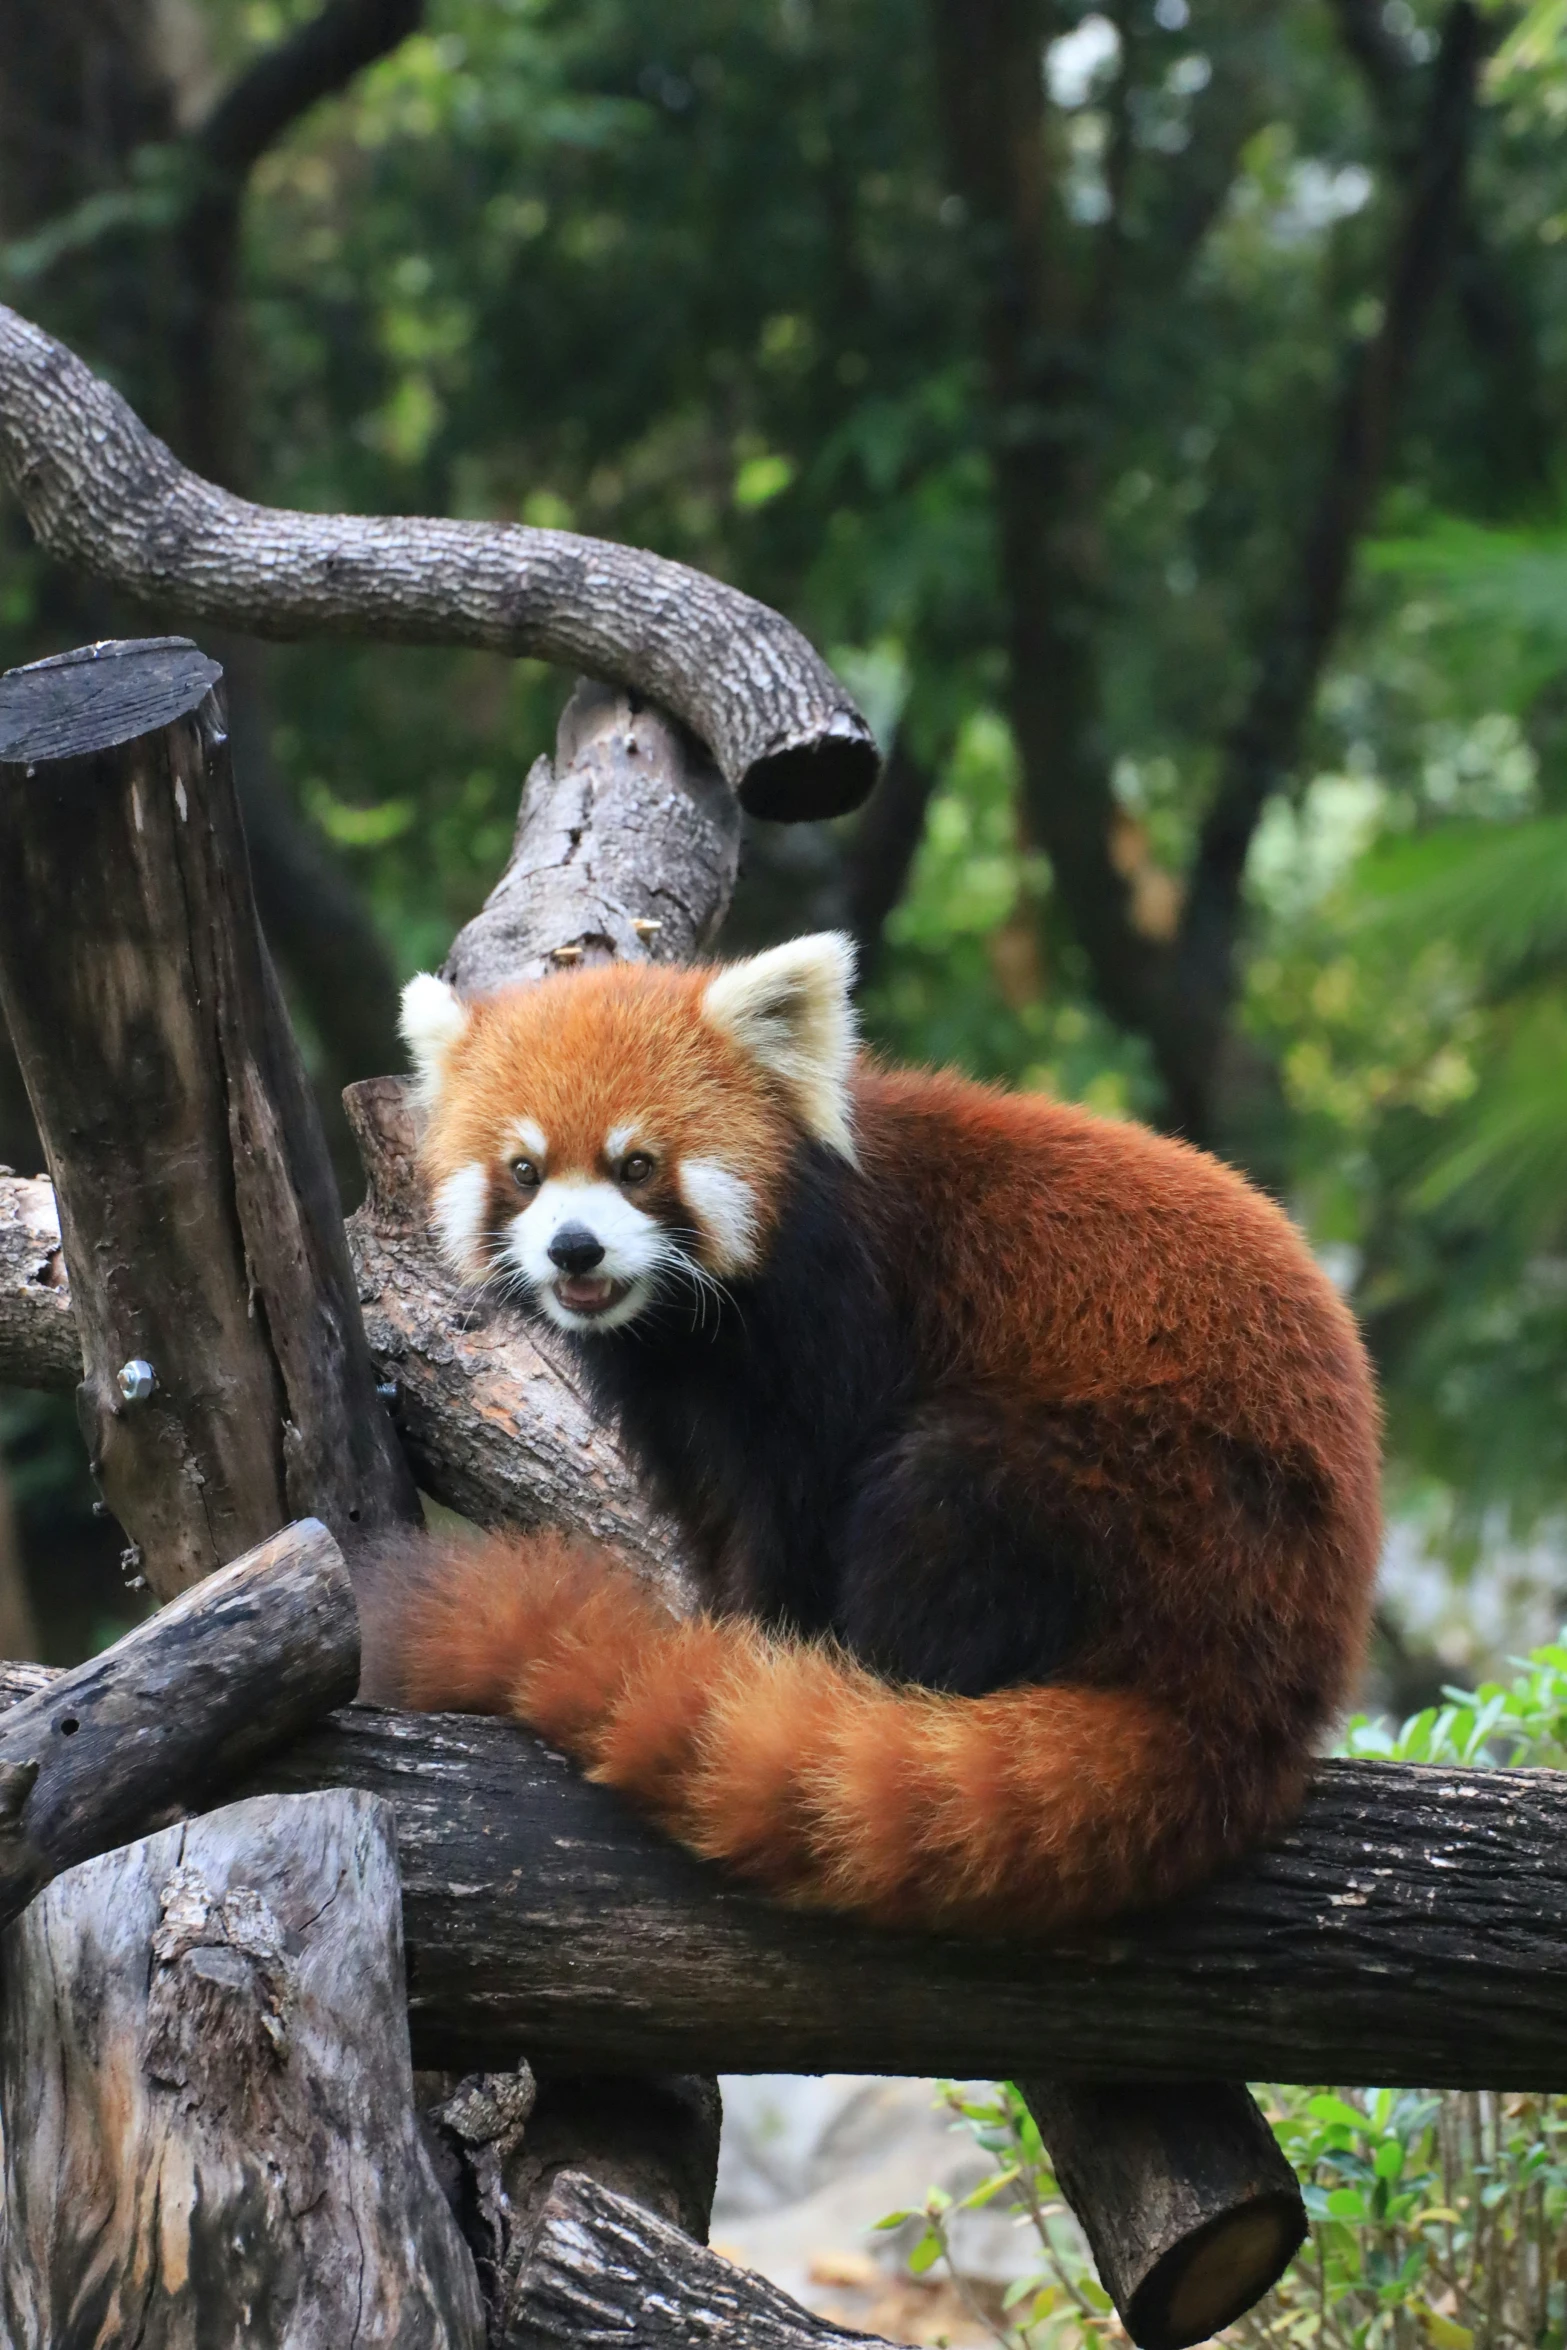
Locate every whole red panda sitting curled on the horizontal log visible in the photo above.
<box><xmin>364</xmin><ymin>935</ymin><xmax>1379</xmax><ymax>1934</ymax></box>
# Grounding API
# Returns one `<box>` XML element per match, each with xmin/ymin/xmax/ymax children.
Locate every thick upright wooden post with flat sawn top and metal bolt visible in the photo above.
<box><xmin>0</xmin><ymin>639</ymin><xmax>416</xmax><ymax>1598</ymax></box>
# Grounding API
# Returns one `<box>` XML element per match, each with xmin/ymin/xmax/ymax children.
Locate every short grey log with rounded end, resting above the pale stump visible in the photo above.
<box><xmin>0</xmin><ymin>1518</ymin><xmax>359</xmax><ymax>1925</ymax></box>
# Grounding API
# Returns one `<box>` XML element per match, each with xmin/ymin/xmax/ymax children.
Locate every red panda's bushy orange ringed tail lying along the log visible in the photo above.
<box><xmin>357</xmin><ymin>1535</ymin><xmax>1304</xmax><ymax>1932</ymax></box>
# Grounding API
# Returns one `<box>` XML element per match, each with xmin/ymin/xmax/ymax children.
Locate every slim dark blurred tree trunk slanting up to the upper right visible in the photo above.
<box><xmin>1165</xmin><ymin>0</ymin><xmax>1485</xmax><ymax>1135</ymax></box>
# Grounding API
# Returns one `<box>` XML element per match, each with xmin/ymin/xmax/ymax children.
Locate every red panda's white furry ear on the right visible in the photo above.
<box><xmin>702</xmin><ymin>931</ymin><xmax>855</xmax><ymax>1161</ymax></box>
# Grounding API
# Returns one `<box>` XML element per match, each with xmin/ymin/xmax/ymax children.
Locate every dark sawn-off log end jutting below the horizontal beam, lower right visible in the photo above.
<box><xmin>1017</xmin><ymin>2080</ymin><xmax>1306</xmax><ymax>2350</ymax></box>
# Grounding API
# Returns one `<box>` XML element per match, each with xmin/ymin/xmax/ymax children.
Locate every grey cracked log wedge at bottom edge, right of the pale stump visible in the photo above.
<box><xmin>500</xmin><ymin>2171</ymin><xmax>876</xmax><ymax>2350</ymax></box>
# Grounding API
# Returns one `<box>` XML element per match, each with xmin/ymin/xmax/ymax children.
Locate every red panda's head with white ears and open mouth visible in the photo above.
<box><xmin>402</xmin><ymin>931</ymin><xmax>855</xmax><ymax>1330</ymax></box>
